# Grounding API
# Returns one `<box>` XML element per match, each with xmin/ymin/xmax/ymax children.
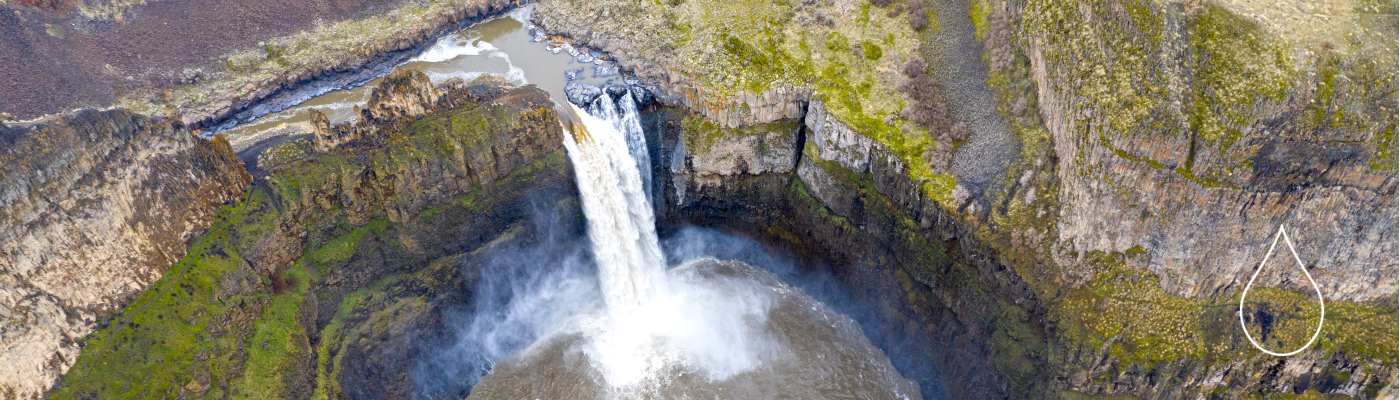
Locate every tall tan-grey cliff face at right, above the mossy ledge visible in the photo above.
<box><xmin>1007</xmin><ymin>1</ymin><xmax>1397</xmax><ymax>301</ymax></box>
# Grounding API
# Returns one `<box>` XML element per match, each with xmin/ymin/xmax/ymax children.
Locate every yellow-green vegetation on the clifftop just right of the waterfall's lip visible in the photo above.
<box><xmin>542</xmin><ymin>0</ymin><xmax>956</xmax><ymax>206</ymax></box>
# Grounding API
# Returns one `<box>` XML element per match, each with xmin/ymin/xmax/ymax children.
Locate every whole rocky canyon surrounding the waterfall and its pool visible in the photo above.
<box><xmin>0</xmin><ymin>0</ymin><xmax>1400</xmax><ymax>399</ymax></box>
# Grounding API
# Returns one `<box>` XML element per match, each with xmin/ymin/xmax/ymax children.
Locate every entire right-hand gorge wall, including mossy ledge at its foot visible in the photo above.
<box><xmin>972</xmin><ymin>1</ymin><xmax>1397</xmax><ymax>399</ymax></box>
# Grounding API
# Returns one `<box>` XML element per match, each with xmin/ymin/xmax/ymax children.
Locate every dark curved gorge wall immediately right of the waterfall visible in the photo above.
<box><xmin>645</xmin><ymin>102</ymin><xmax>1043</xmax><ymax>399</ymax></box>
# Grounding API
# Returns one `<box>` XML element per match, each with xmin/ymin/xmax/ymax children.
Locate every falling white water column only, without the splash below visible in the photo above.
<box><xmin>564</xmin><ymin>92</ymin><xmax>666</xmax><ymax>312</ymax></box>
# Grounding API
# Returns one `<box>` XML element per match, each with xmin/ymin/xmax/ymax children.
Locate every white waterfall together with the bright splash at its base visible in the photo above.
<box><xmin>564</xmin><ymin>92</ymin><xmax>778</xmax><ymax>397</ymax></box>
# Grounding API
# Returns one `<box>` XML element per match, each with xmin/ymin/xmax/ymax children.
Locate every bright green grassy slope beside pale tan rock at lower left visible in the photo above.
<box><xmin>50</xmin><ymin>190</ymin><xmax>276</xmax><ymax>399</ymax></box>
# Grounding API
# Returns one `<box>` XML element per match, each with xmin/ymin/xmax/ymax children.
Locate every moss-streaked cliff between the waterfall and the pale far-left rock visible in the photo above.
<box><xmin>50</xmin><ymin>71</ymin><xmax>580</xmax><ymax>399</ymax></box>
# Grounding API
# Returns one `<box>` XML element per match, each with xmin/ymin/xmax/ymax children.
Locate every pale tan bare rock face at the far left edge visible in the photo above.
<box><xmin>0</xmin><ymin>110</ymin><xmax>249</xmax><ymax>399</ymax></box>
